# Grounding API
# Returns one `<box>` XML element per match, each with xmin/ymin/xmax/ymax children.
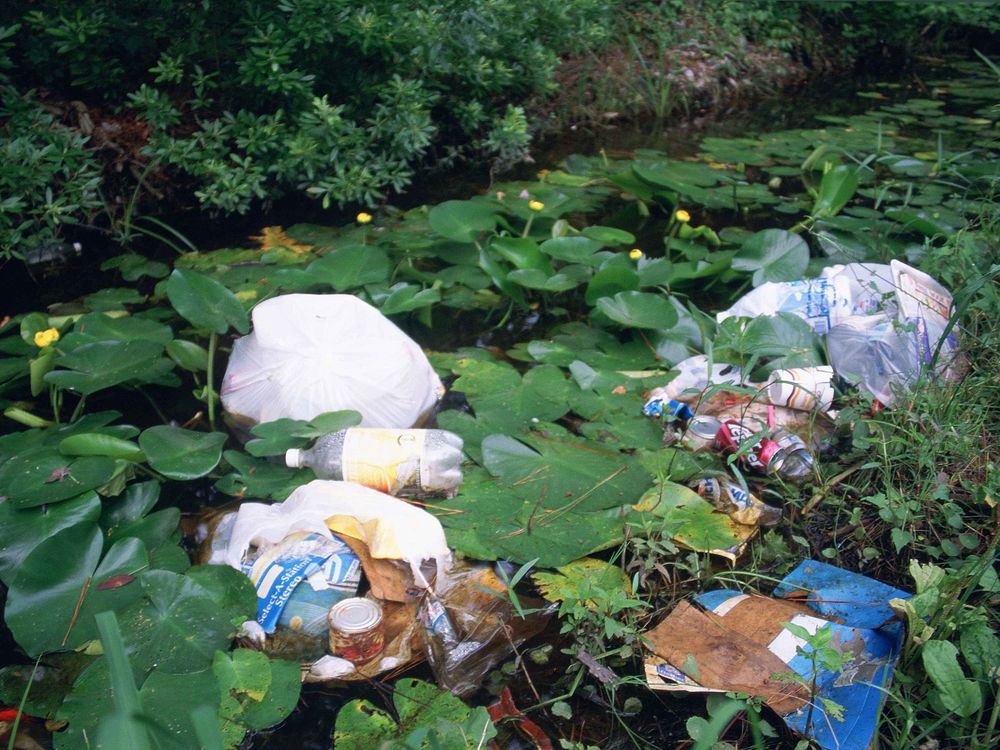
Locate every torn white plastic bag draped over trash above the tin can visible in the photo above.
<box><xmin>223</xmin><ymin>479</ymin><xmax>451</xmax><ymax>588</ymax></box>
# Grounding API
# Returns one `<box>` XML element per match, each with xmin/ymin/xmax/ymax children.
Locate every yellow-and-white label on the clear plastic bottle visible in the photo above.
<box><xmin>341</xmin><ymin>429</ymin><xmax>427</xmax><ymax>495</ymax></box>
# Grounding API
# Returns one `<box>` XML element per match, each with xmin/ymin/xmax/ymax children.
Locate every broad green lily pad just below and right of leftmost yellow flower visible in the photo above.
<box><xmin>43</xmin><ymin>339</ymin><xmax>174</xmax><ymax>396</ymax></box>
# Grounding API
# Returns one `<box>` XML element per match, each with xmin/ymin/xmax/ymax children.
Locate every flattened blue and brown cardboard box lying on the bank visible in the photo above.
<box><xmin>645</xmin><ymin>560</ymin><xmax>910</xmax><ymax>750</ymax></box>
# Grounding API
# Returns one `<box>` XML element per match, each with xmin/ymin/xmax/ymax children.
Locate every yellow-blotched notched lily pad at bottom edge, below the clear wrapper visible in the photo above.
<box><xmin>333</xmin><ymin>678</ymin><xmax>496</xmax><ymax>750</ymax></box>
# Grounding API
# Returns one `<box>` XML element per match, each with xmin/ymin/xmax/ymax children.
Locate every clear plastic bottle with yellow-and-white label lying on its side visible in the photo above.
<box><xmin>285</xmin><ymin>427</ymin><xmax>464</xmax><ymax>496</ymax></box>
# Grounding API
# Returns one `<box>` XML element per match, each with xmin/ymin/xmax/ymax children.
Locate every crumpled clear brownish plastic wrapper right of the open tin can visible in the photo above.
<box><xmin>418</xmin><ymin>565</ymin><xmax>555</xmax><ymax>696</ymax></box>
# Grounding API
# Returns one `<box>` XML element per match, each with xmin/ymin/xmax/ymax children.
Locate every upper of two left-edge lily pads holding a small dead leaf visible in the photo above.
<box><xmin>0</xmin><ymin>447</ymin><xmax>118</xmax><ymax>509</ymax></box>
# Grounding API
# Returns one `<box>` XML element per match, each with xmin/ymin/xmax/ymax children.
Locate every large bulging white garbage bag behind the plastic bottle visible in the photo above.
<box><xmin>221</xmin><ymin>294</ymin><xmax>444</xmax><ymax>428</ymax></box>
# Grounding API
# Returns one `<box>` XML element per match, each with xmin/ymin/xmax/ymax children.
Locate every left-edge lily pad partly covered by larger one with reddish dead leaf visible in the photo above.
<box><xmin>0</xmin><ymin>492</ymin><xmax>101</xmax><ymax>587</ymax></box>
